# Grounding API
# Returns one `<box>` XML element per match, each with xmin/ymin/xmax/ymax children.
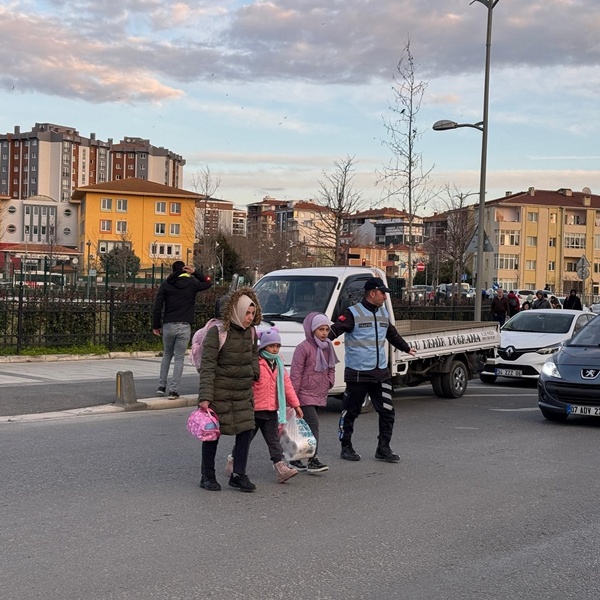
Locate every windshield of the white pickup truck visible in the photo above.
<box><xmin>254</xmin><ymin>273</ymin><xmax>337</xmax><ymax>323</ymax></box>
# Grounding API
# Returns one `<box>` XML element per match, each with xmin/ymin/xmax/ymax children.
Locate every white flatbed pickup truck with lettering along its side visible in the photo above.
<box><xmin>254</xmin><ymin>267</ymin><xmax>500</xmax><ymax>398</ymax></box>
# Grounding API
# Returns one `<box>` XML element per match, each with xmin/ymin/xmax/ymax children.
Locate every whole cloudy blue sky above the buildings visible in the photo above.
<box><xmin>0</xmin><ymin>0</ymin><xmax>600</xmax><ymax>214</ymax></box>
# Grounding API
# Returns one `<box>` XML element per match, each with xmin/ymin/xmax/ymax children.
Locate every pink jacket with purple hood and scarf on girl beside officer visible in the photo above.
<box><xmin>290</xmin><ymin>313</ymin><xmax>335</xmax><ymax>406</ymax></box>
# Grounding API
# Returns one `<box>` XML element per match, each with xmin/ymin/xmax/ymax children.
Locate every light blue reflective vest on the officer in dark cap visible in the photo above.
<box><xmin>345</xmin><ymin>304</ymin><xmax>390</xmax><ymax>371</ymax></box>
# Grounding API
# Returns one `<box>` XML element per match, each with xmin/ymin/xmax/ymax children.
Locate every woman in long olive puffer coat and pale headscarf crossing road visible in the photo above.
<box><xmin>198</xmin><ymin>287</ymin><xmax>262</xmax><ymax>492</ymax></box>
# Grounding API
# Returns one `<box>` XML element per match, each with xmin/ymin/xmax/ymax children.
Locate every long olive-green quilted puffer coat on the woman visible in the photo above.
<box><xmin>198</xmin><ymin>323</ymin><xmax>259</xmax><ymax>435</ymax></box>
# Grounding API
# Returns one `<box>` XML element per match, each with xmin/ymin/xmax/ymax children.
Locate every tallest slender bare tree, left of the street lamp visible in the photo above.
<box><xmin>378</xmin><ymin>38</ymin><xmax>433</xmax><ymax>291</ymax></box>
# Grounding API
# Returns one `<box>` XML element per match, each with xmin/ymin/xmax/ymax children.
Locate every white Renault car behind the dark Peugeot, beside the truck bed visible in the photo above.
<box><xmin>479</xmin><ymin>308</ymin><xmax>596</xmax><ymax>383</ymax></box>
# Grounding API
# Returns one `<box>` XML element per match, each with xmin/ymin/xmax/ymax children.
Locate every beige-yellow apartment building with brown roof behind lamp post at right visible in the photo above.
<box><xmin>484</xmin><ymin>187</ymin><xmax>600</xmax><ymax>297</ymax></box>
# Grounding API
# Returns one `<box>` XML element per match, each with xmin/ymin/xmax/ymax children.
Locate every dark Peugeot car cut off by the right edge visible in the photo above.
<box><xmin>538</xmin><ymin>317</ymin><xmax>600</xmax><ymax>422</ymax></box>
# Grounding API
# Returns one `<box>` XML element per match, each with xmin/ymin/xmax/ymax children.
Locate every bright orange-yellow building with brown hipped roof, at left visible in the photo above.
<box><xmin>71</xmin><ymin>178</ymin><xmax>202</xmax><ymax>273</ymax></box>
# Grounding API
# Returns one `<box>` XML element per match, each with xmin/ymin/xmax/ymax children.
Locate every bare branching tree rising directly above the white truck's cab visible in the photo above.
<box><xmin>312</xmin><ymin>155</ymin><xmax>363</xmax><ymax>265</ymax></box>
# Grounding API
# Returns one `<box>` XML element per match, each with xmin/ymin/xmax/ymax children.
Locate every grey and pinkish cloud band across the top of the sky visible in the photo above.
<box><xmin>0</xmin><ymin>0</ymin><xmax>600</xmax><ymax>103</ymax></box>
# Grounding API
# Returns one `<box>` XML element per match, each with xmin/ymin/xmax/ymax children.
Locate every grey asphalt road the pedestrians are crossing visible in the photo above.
<box><xmin>0</xmin><ymin>382</ymin><xmax>600</xmax><ymax>600</ymax></box>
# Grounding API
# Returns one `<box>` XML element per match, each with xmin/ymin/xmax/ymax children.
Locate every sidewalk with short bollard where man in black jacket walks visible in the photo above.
<box><xmin>0</xmin><ymin>352</ymin><xmax>198</xmax><ymax>423</ymax></box>
